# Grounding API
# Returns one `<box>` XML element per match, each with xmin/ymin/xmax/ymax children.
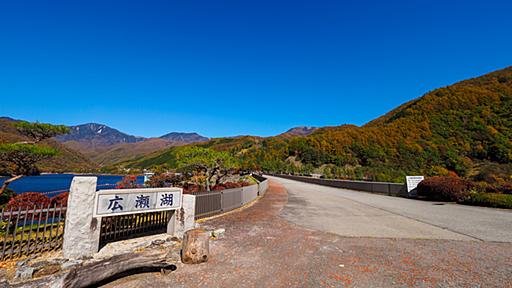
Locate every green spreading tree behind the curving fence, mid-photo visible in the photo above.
<box><xmin>176</xmin><ymin>146</ymin><xmax>239</xmax><ymax>191</ymax></box>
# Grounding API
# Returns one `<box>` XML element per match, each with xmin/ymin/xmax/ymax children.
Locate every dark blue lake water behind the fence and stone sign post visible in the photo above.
<box><xmin>0</xmin><ymin>174</ymin><xmax>144</xmax><ymax>196</ymax></box>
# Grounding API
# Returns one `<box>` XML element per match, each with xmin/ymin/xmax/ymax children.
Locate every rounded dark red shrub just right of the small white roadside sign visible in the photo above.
<box><xmin>417</xmin><ymin>177</ymin><xmax>473</xmax><ymax>201</ymax></box>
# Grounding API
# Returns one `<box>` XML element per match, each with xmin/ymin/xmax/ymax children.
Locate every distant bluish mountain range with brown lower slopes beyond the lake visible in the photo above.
<box><xmin>0</xmin><ymin>117</ymin><xmax>315</xmax><ymax>172</ymax></box>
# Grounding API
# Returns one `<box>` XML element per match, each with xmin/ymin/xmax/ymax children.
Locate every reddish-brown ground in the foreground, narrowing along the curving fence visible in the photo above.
<box><xmin>104</xmin><ymin>182</ymin><xmax>512</xmax><ymax>288</ymax></box>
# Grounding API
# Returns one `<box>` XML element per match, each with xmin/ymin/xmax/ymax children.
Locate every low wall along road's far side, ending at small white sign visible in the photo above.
<box><xmin>273</xmin><ymin>174</ymin><xmax>408</xmax><ymax>197</ymax></box>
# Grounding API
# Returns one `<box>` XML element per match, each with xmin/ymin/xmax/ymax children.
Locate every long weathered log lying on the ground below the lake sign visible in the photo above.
<box><xmin>62</xmin><ymin>247</ymin><xmax>176</xmax><ymax>288</ymax></box>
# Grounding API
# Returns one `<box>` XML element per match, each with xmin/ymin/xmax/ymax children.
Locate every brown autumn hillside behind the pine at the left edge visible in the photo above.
<box><xmin>0</xmin><ymin>117</ymin><xmax>96</xmax><ymax>173</ymax></box>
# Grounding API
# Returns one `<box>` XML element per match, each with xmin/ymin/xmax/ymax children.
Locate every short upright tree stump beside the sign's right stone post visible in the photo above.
<box><xmin>181</xmin><ymin>228</ymin><xmax>210</xmax><ymax>264</ymax></box>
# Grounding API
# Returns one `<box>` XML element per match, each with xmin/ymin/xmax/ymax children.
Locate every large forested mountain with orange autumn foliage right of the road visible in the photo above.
<box><xmin>122</xmin><ymin>67</ymin><xmax>512</xmax><ymax>182</ymax></box>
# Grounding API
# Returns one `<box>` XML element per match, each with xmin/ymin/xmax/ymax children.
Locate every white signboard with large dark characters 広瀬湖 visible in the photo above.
<box><xmin>94</xmin><ymin>187</ymin><xmax>183</xmax><ymax>217</ymax></box>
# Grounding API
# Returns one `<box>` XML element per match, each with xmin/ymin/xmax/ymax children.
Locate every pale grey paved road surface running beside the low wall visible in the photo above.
<box><xmin>270</xmin><ymin>177</ymin><xmax>512</xmax><ymax>242</ymax></box>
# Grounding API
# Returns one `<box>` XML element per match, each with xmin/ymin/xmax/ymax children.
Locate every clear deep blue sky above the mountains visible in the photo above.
<box><xmin>0</xmin><ymin>0</ymin><xmax>512</xmax><ymax>137</ymax></box>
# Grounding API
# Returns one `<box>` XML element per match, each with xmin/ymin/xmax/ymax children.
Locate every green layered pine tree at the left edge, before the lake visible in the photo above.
<box><xmin>0</xmin><ymin>121</ymin><xmax>69</xmax><ymax>195</ymax></box>
